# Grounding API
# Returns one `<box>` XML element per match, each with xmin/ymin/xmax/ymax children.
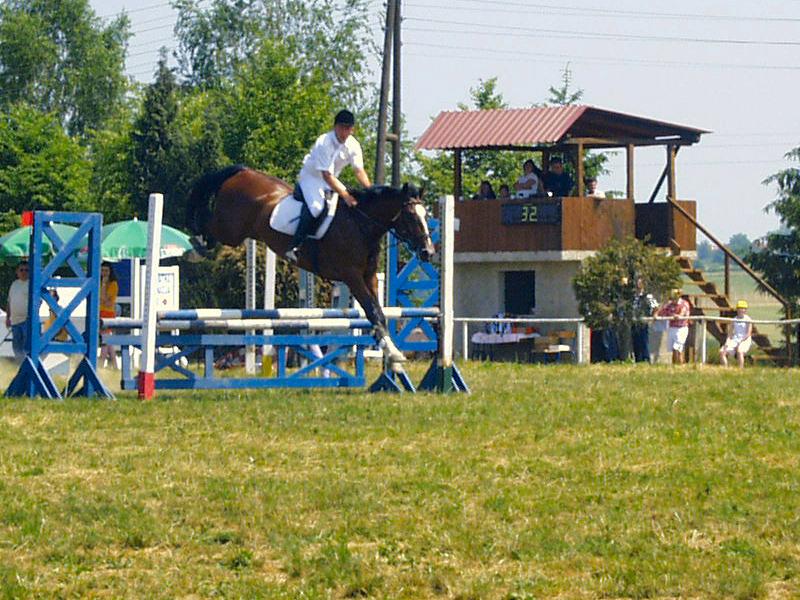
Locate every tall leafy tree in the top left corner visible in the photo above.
<box><xmin>0</xmin><ymin>0</ymin><xmax>130</xmax><ymax>135</ymax></box>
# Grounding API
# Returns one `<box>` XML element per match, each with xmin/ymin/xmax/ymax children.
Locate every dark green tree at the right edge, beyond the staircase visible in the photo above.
<box><xmin>746</xmin><ymin>147</ymin><xmax>800</xmax><ymax>315</ymax></box>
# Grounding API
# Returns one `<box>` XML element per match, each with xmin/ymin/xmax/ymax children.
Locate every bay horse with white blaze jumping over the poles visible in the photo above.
<box><xmin>186</xmin><ymin>165</ymin><xmax>435</xmax><ymax>363</ymax></box>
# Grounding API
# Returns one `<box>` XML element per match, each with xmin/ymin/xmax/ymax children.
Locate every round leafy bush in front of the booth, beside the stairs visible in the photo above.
<box><xmin>572</xmin><ymin>237</ymin><xmax>681</xmax><ymax>356</ymax></box>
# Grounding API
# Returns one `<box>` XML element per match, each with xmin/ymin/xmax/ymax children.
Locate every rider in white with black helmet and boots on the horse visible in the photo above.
<box><xmin>286</xmin><ymin>110</ymin><xmax>371</xmax><ymax>261</ymax></box>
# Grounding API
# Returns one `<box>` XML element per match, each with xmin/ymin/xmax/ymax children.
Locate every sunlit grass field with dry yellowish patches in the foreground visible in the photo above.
<box><xmin>0</xmin><ymin>363</ymin><xmax>800</xmax><ymax>599</ymax></box>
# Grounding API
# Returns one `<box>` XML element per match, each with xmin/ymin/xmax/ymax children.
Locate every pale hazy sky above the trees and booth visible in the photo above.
<box><xmin>91</xmin><ymin>0</ymin><xmax>800</xmax><ymax>241</ymax></box>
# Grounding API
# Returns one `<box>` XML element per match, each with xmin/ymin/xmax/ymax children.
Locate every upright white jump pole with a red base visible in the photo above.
<box><xmin>138</xmin><ymin>194</ymin><xmax>164</xmax><ymax>400</ymax></box>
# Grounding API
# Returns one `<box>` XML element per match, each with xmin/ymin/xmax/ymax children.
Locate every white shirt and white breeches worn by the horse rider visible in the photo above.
<box><xmin>298</xmin><ymin>131</ymin><xmax>364</xmax><ymax>217</ymax></box>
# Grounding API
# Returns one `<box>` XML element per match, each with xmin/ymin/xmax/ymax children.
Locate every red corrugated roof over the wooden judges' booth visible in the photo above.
<box><xmin>416</xmin><ymin>106</ymin><xmax>707</xmax><ymax>150</ymax></box>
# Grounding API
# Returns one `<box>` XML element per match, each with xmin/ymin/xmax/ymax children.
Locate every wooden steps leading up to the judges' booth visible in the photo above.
<box><xmin>671</xmin><ymin>251</ymin><xmax>789</xmax><ymax>365</ymax></box>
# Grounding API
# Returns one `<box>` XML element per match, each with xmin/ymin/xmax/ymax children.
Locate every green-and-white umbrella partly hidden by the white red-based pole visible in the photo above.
<box><xmin>100</xmin><ymin>219</ymin><xmax>192</xmax><ymax>259</ymax></box>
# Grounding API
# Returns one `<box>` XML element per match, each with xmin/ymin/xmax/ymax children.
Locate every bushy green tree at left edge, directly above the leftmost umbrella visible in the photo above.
<box><xmin>0</xmin><ymin>103</ymin><xmax>92</xmax><ymax>212</ymax></box>
